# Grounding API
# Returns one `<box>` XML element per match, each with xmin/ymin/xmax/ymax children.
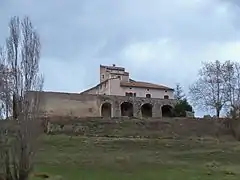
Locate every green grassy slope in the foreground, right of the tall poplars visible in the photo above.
<box><xmin>32</xmin><ymin>135</ymin><xmax>240</xmax><ymax>180</ymax></box>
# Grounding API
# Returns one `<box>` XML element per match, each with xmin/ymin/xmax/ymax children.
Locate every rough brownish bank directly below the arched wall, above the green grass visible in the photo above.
<box><xmin>43</xmin><ymin>117</ymin><xmax>233</xmax><ymax>139</ymax></box>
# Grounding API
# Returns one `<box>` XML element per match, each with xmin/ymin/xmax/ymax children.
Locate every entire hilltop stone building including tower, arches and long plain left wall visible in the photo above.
<box><xmin>33</xmin><ymin>65</ymin><xmax>175</xmax><ymax>118</ymax></box>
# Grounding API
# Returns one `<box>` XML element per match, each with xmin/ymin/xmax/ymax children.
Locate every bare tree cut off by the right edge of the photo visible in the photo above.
<box><xmin>223</xmin><ymin>61</ymin><xmax>240</xmax><ymax>116</ymax></box>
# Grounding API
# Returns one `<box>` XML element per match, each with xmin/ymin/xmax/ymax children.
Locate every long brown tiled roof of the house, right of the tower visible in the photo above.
<box><xmin>120</xmin><ymin>79</ymin><xmax>173</xmax><ymax>90</ymax></box>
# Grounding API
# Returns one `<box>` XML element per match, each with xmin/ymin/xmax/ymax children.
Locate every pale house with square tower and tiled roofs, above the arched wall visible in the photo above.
<box><xmin>82</xmin><ymin>64</ymin><xmax>174</xmax><ymax>99</ymax></box>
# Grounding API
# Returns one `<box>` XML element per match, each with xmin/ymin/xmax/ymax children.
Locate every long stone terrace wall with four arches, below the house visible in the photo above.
<box><xmin>29</xmin><ymin>92</ymin><xmax>175</xmax><ymax>118</ymax></box>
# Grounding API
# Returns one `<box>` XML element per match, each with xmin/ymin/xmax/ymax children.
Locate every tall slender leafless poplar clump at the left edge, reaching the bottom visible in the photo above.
<box><xmin>0</xmin><ymin>17</ymin><xmax>43</xmax><ymax>180</ymax></box>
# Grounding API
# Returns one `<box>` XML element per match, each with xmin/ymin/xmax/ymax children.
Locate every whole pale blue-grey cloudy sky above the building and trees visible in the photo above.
<box><xmin>0</xmin><ymin>0</ymin><xmax>240</xmax><ymax>115</ymax></box>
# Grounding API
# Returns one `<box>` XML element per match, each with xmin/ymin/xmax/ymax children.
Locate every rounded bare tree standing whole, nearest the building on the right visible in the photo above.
<box><xmin>189</xmin><ymin>60</ymin><xmax>226</xmax><ymax>117</ymax></box>
